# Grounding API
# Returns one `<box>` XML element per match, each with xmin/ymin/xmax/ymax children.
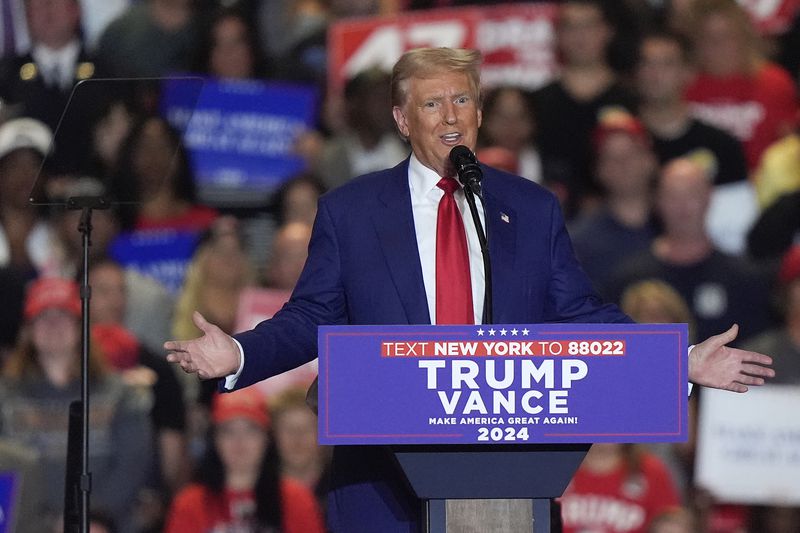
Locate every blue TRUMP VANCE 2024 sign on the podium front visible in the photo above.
<box><xmin>319</xmin><ymin>324</ymin><xmax>688</xmax><ymax>444</ymax></box>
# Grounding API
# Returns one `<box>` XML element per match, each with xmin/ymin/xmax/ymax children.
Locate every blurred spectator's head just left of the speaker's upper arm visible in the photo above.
<box><xmin>264</xmin><ymin>222</ymin><xmax>311</xmax><ymax>291</ymax></box>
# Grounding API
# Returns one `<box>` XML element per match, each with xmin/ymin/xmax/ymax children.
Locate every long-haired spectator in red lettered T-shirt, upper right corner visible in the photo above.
<box><xmin>686</xmin><ymin>0</ymin><xmax>798</xmax><ymax>170</ymax></box>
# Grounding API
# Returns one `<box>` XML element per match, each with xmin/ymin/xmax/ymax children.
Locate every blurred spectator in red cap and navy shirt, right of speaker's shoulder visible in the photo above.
<box><xmin>570</xmin><ymin>110</ymin><xmax>658</xmax><ymax>295</ymax></box>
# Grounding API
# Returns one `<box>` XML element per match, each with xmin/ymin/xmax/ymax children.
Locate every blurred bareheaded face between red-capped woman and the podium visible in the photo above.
<box><xmin>270</xmin><ymin>386</ymin><xmax>330</xmax><ymax>503</ymax></box>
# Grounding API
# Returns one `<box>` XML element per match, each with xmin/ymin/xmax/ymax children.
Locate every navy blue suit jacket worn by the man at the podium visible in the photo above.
<box><xmin>236</xmin><ymin>160</ymin><xmax>630</xmax><ymax>533</ymax></box>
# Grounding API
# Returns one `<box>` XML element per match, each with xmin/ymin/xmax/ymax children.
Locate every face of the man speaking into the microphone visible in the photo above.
<box><xmin>392</xmin><ymin>72</ymin><xmax>481</xmax><ymax>176</ymax></box>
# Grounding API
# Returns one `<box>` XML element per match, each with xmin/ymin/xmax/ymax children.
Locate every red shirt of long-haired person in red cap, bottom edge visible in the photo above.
<box><xmin>164</xmin><ymin>479</ymin><xmax>325</xmax><ymax>533</ymax></box>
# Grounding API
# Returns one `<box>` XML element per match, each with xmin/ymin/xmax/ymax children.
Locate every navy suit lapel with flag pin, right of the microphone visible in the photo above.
<box><xmin>483</xmin><ymin>172</ymin><xmax>518</xmax><ymax>323</ymax></box>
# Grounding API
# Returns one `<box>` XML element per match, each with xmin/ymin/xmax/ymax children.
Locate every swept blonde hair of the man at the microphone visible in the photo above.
<box><xmin>392</xmin><ymin>47</ymin><xmax>483</xmax><ymax>107</ymax></box>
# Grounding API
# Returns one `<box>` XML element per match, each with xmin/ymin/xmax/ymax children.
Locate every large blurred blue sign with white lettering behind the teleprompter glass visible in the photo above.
<box><xmin>162</xmin><ymin>79</ymin><xmax>318</xmax><ymax>205</ymax></box>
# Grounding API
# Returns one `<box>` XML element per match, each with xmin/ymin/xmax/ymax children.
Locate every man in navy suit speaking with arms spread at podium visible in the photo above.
<box><xmin>165</xmin><ymin>48</ymin><xmax>772</xmax><ymax>533</ymax></box>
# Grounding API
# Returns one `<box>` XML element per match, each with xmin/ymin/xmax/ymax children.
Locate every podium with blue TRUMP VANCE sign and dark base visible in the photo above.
<box><xmin>319</xmin><ymin>324</ymin><xmax>688</xmax><ymax>533</ymax></box>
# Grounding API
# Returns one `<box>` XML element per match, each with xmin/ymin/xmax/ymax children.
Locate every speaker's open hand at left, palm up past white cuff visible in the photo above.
<box><xmin>164</xmin><ymin>311</ymin><xmax>241</xmax><ymax>379</ymax></box>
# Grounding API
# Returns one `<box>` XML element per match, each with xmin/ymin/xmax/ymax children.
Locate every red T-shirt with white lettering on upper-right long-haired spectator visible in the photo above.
<box><xmin>686</xmin><ymin>63</ymin><xmax>797</xmax><ymax>170</ymax></box>
